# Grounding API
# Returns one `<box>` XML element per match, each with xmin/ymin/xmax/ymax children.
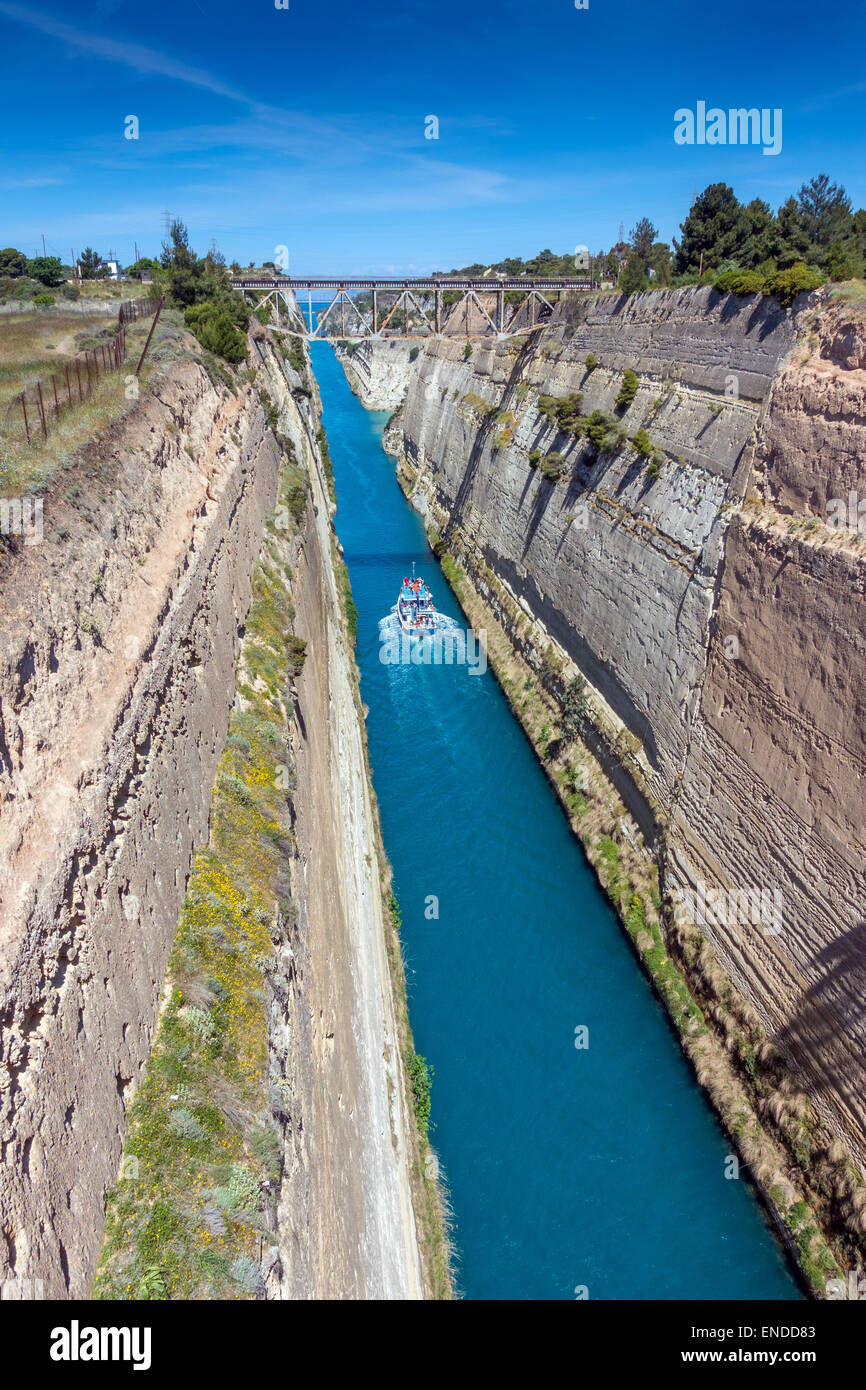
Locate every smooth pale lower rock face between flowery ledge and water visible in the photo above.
<box><xmin>252</xmin><ymin>341</ymin><xmax>424</xmax><ymax>1300</ymax></box>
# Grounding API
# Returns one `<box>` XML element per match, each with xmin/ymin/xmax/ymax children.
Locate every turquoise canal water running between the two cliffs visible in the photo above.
<box><xmin>311</xmin><ymin>343</ymin><xmax>799</xmax><ymax>1300</ymax></box>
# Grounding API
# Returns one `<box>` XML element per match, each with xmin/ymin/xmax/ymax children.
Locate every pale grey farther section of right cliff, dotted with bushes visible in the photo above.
<box><xmin>403</xmin><ymin>292</ymin><xmax>791</xmax><ymax>808</ymax></box>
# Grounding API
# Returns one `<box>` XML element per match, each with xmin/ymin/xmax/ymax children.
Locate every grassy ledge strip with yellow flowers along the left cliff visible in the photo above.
<box><xmin>93</xmin><ymin>470</ymin><xmax>303</xmax><ymax>1300</ymax></box>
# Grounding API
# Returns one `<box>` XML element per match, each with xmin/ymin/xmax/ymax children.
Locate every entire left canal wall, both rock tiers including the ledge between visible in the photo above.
<box><xmin>0</xmin><ymin>325</ymin><xmax>425</xmax><ymax>1298</ymax></box>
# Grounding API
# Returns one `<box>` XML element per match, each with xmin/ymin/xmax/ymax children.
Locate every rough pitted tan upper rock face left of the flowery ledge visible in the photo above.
<box><xmin>0</xmin><ymin>364</ymin><xmax>278</xmax><ymax>1297</ymax></box>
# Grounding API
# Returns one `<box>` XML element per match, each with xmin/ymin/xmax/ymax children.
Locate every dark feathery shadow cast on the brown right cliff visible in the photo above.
<box><xmin>774</xmin><ymin>922</ymin><xmax>866</xmax><ymax>1134</ymax></box>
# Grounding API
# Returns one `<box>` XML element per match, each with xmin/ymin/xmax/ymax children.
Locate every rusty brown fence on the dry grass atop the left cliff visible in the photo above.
<box><xmin>4</xmin><ymin>299</ymin><xmax>163</xmax><ymax>443</ymax></box>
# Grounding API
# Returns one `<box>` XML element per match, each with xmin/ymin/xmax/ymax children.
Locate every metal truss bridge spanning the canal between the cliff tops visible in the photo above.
<box><xmin>231</xmin><ymin>275</ymin><xmax>595</xmax><ymax>341</ymax></box>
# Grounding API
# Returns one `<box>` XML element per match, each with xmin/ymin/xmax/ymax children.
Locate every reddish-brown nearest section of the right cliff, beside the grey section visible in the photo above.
<box><xmin>670</xmin><ymin>313</ymin><xmax>866</xmax><ymax>1163</ymax></box>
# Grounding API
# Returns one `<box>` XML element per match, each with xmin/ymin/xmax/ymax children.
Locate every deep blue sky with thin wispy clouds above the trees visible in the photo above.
<box><xmin>0</xmin><ymin>0</ymin><xmax>866</xmax><ymax>274</ymax></box>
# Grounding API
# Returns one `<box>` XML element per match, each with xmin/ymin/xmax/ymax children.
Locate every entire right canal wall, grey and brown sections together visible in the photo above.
<box><xmin>341</xmin><ymin>289</ymin><xmax>866</xmax><ymax>1284</ymax></box>
